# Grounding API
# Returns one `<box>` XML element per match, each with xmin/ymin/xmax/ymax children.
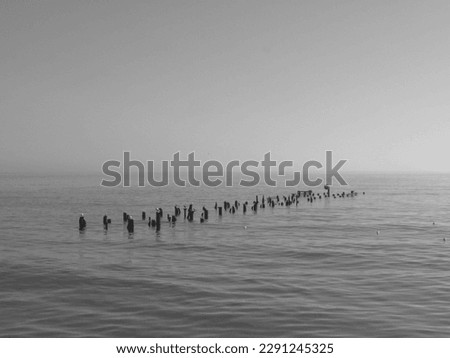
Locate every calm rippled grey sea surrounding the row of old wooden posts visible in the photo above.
<box><xmin>0</xmin><ymin>174</ymin><xmax>450</xmax><ymax>337</ymax></box>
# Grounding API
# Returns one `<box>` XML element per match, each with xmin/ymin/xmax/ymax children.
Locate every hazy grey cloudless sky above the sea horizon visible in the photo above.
<box><xmin>0</xmin><ymin>0</ymin><xmax>450</xmax><ymax>172</ymax></box>
